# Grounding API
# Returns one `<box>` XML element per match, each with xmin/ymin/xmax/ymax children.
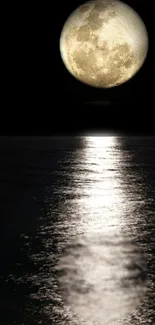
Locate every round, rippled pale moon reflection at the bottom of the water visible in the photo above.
<box><xmin>57</xmin><ymin>232</ymin><xmax>147</xmax><ymax>325</ymax></box>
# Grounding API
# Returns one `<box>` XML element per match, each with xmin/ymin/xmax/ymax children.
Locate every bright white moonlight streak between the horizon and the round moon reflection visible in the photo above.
<box><xmin>73</xmin><ymin>136</ymin><xmax>127</xmax><ymax>232</ymax></box>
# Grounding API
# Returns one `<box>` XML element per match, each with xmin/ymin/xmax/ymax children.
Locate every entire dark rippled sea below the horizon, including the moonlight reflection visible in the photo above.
<box><xmin>0</xmin><ymin>136</ymin><xmax>155</xmax><ymax>325</ymax></box>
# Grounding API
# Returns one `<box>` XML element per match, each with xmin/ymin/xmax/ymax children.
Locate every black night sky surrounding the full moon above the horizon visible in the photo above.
<box><xmin>1</xmin><ymin>0</ymin><xmax>155</xmax><ymax>134</ymax></box>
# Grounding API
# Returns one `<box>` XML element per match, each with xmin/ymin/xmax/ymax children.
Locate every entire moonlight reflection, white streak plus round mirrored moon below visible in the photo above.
<box><xmin>57</xmin><ymin>137</ymin><xmax>147</xmax><ymax>325</ymax></box>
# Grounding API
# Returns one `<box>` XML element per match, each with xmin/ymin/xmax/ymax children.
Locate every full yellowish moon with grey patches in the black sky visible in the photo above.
<box><xmin>60</xmin><ymin>0</ymin><xmax>148</xmax><ymax>88</ymax></box>
